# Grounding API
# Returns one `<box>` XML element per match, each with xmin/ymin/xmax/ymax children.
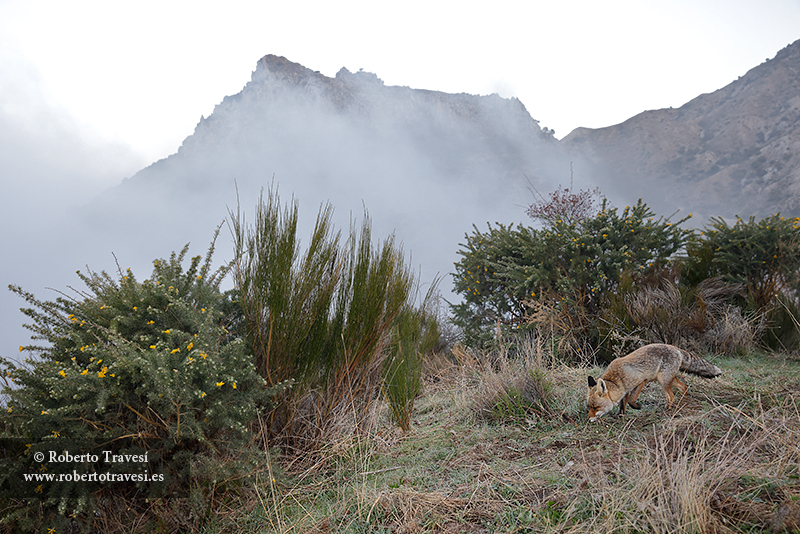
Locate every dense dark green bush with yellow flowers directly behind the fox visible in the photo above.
<box><xmin>453</xmin><ymin>201</ymin><xmax>690</xmax><ymax>350</ymax></box>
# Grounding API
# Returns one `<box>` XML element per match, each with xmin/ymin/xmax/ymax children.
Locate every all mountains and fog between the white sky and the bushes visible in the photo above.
<box><xmin>7</xmin><ymin>41</ymin><xmax>800</xmax><ymax>364</ymax></box>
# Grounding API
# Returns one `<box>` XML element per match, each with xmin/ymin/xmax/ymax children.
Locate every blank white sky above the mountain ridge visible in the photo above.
<box><xmin>0</xmin><ymin>0</ymin><xmax>800</xmax><ymax>175</ymax></box>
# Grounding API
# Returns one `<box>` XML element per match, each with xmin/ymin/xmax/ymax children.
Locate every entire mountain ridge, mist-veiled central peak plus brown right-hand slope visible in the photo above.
<box><xmin>84</xmin><ymin>41</ymin><xmax>800</xmax><ymax>293</ymax></box>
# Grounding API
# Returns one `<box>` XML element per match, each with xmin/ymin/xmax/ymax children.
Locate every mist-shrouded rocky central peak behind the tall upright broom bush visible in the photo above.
<box><xmin>92</xmin><ymin>55</ymin><xmax>570</xmax><ymax>302</ymax></box>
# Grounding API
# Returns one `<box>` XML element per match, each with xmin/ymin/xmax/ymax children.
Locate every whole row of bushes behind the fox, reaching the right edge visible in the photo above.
<box><xmin>453</xmin><ymin>184</ymin><xmax>800</xmax><ymax>359</ymax></box>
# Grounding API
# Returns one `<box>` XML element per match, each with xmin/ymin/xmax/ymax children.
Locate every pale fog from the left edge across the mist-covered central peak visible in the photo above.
<box><xmin>0</xmin><ymin>58</ymin><xmax>591</xmax><ymax>366</ymax></box>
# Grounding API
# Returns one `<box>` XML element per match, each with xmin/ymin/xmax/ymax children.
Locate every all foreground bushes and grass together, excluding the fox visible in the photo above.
<box><xmin>0</xmin><ymin>183</ymin><xmax>800</xmax><ymax>533</ymax></box>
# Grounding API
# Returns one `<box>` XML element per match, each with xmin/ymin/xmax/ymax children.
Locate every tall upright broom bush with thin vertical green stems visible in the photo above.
<box><xmin>231</xmin><ymin>189</ymin><xmax>444</xmax><ymax>459</ymax></box>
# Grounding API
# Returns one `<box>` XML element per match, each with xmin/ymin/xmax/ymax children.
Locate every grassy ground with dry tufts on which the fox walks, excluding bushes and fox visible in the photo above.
<box><xmin>207</xmin><ymin>356</ymin><xmax>800</xmax><ymax>533</ymax></box>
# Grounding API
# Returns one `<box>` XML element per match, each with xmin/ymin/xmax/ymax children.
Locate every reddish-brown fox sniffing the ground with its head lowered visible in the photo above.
<box><xmin>586</xmin><ymin>343</ymin><xmax>722</xmax><ymax>422</ymax></box>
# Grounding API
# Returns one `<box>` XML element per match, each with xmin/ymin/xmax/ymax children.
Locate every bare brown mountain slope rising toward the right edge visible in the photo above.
<box><xmin>562</xmin><ymin>41</ymin><xmax>800</xmax><ymax>218</ymax></box>
